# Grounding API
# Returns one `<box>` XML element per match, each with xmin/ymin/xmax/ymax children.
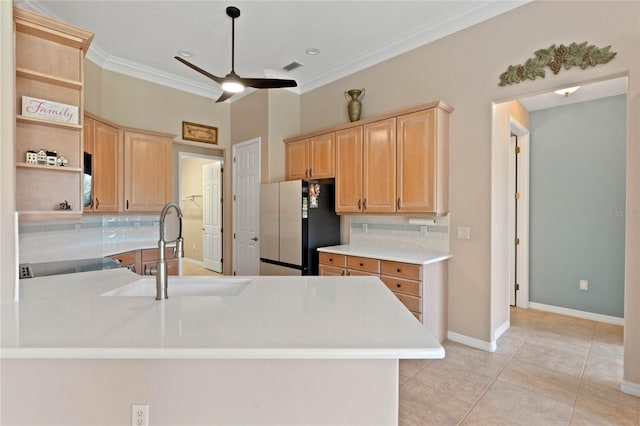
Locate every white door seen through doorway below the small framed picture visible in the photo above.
<box><xmin>202</xmin><ymin>161</ymin><xmax>222</xmax><ymax>273</ymax></box>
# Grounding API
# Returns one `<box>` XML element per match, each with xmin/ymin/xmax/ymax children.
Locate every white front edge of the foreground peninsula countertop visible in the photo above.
<box><xmin>0</xmin><ymin>346</ymin><xmax>445</xmax><ymax>360</ymax></box>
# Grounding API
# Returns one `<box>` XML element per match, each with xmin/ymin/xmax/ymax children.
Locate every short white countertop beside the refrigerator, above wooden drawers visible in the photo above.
<box><xmin>318</xmin><ymin>244</ymin><xmax>453</xmax><ymax>265</ymax></box>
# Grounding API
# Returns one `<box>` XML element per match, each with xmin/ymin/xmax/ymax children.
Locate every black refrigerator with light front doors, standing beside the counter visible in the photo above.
<box><xmin>260</xmin><ymin>180</ymin><xmax>340</xmax><ymax>275</ymax></box>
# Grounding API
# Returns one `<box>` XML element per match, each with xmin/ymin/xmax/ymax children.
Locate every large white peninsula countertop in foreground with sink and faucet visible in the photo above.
<box><xmin>0</xmin><ymin>269</ymin><xmax>444</xmax><ymax>359</ymax></box>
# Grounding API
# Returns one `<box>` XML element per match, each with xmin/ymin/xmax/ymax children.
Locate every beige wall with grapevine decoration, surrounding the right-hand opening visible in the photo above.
<box><xmin>300</xmin><ymin>1</ymin><xmax>640</xmax><ymax>383</ymax></box>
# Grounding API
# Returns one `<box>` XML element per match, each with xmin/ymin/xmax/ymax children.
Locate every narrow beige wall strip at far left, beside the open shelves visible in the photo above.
<box><xmin>0</xmin><ymin>1</ymin><xmax>16</xmax><ymax>303</ymax></box>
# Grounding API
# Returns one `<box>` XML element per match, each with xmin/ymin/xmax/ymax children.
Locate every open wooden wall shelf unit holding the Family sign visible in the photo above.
<box><xmin>13</xmin><ymin>8</ymin><xmax>93</xmax><ymax>220</ymax></box>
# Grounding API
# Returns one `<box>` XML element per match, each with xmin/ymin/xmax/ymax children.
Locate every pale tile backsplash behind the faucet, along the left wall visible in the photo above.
<box><xmin>18</xmin><ymin>215</ymin><xmax>159</xmax><ymax>263</ymax></box>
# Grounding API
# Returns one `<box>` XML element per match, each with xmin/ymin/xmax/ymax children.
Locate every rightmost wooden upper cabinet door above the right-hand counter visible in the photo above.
<box><xmin>397</xmin><ymin>110</ymin><xmax>437</xmax><ymax>213</ymax></box>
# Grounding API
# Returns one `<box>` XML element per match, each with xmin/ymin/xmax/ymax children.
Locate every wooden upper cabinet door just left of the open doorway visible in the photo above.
<box><xmin>124</xmin><ymin>131</ymin><xmax>171</xmax><ymax>212</ymax></box>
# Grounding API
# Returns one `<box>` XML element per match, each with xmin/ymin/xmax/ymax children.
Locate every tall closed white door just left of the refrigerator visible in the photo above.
<box><xmin>233</xmin><ymin>138</ymin><xmax>260</xmax><ymax>275</ymax></box>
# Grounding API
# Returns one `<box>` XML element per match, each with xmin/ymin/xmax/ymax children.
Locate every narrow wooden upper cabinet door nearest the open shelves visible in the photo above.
<box><xmin>92</xmin><ymin>121</ymin><xmax>122</xmax><ymax>213</ymax></box>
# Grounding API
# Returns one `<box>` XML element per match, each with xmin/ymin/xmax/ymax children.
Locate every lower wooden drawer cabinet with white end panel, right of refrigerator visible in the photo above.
<box><xmin>318</xmin><ymin>252</ymin><xmax>447</xmax><ymax>342</ymax></box>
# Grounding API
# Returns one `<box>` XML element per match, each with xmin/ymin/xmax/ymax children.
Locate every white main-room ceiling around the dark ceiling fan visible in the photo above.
<box><xmin>14</xmin><ymin>0</ymin><xmax>529</xmax><ymax>100</ymax></box>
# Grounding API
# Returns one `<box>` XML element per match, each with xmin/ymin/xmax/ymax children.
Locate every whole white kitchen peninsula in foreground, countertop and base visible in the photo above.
<box><xmin>1</xmin><ymin>269</ymin><xmax>444</xmax><ymax>425</ymax></box>
